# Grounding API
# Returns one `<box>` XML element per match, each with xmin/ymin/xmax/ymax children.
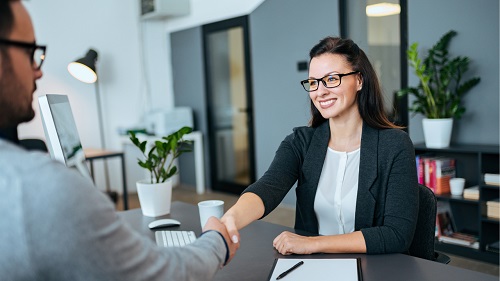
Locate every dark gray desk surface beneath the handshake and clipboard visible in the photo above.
<box><xmin>119</xmin><ymin>202</ymin><xmax>498</xmax><ymax>281</ymax></box>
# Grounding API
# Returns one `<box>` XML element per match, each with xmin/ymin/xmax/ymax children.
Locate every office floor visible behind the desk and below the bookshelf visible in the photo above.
<box><xmin>117</xmin><ymin>186</ymin><xmax>499</xmax><ymax>276</ymax></box>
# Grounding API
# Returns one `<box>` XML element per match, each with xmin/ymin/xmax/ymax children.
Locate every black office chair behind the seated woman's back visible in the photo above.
<box><xmin>408</xmin><ymin>184</ymin><xmax>451</xmax><ymax>264</ymax></box>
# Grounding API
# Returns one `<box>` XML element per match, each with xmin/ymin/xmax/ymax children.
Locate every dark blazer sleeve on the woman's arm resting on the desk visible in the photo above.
<box><xmin>361</xmin><ymin>133</ymin><xmax>419</xmax><ymax>254</ymax></box>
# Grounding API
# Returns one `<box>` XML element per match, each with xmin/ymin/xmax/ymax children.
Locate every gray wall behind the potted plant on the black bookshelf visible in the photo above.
<box><xmin>408</xmin><ymin>0</ymin><xmax>499</xmax><ymax>145</ymax></box>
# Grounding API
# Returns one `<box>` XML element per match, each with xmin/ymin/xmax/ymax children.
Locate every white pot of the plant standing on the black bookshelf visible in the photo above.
<box><xmin>422</xmin><ymin>118</ymin><xmax>453</xmax><ymax>148</ymax></box>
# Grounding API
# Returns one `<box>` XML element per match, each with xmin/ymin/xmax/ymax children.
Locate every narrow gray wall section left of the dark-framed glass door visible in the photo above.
<box><xmin>170</xmin><ymin>26</ymin><xmax>210</xmax><ymax>186</ymax></box>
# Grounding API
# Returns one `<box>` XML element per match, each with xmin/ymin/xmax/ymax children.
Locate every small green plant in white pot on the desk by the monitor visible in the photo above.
<box><xmin>129</xmin><ymin>127</ymin><xmax>193</xmax><ymax>217</ymax></box>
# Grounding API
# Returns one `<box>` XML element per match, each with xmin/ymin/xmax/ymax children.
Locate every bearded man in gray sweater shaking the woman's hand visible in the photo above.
<box><xmin>0</xmin><ymin>0</ymin><xmax>239</xmax><ymax>280</ymax></box>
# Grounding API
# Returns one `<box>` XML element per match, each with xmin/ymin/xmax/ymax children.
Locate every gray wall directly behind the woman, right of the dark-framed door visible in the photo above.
<box><xmin>250</xmin><ymin>0</ymin><xmax>340</xmax><ymax>206</ymax></box>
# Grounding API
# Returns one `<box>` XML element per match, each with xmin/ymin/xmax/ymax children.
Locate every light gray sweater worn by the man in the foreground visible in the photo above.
<box><xmin>0</xmin><ymin>139</ymin><xmax>226</xmax><ymax>280</ymax></box>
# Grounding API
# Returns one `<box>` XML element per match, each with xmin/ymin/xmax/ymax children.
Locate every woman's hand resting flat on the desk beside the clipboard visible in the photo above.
<box><xmin>273</xmin><ymin>231</ymin><xmax>314</xmax><ymax>255</ymax></box>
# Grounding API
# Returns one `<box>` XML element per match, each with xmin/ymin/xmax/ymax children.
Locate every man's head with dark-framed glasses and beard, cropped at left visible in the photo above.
<box><xmin>0</xmin><ymin>0</ymin><xmax>42</xmax><ymax>128</ymax></box>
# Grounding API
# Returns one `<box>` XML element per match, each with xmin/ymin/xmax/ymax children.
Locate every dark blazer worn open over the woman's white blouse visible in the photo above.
<box><xmin>244</xmin><ymin>122</ymin><xmax>418</xmax><ymax>254</ymax></box>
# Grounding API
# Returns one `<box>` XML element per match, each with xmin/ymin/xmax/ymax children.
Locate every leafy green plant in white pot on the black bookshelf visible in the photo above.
<box><xmin>398</xmin><ymin>30</ymin><xmax>480</xmax><ymax>148</ymax></box>
